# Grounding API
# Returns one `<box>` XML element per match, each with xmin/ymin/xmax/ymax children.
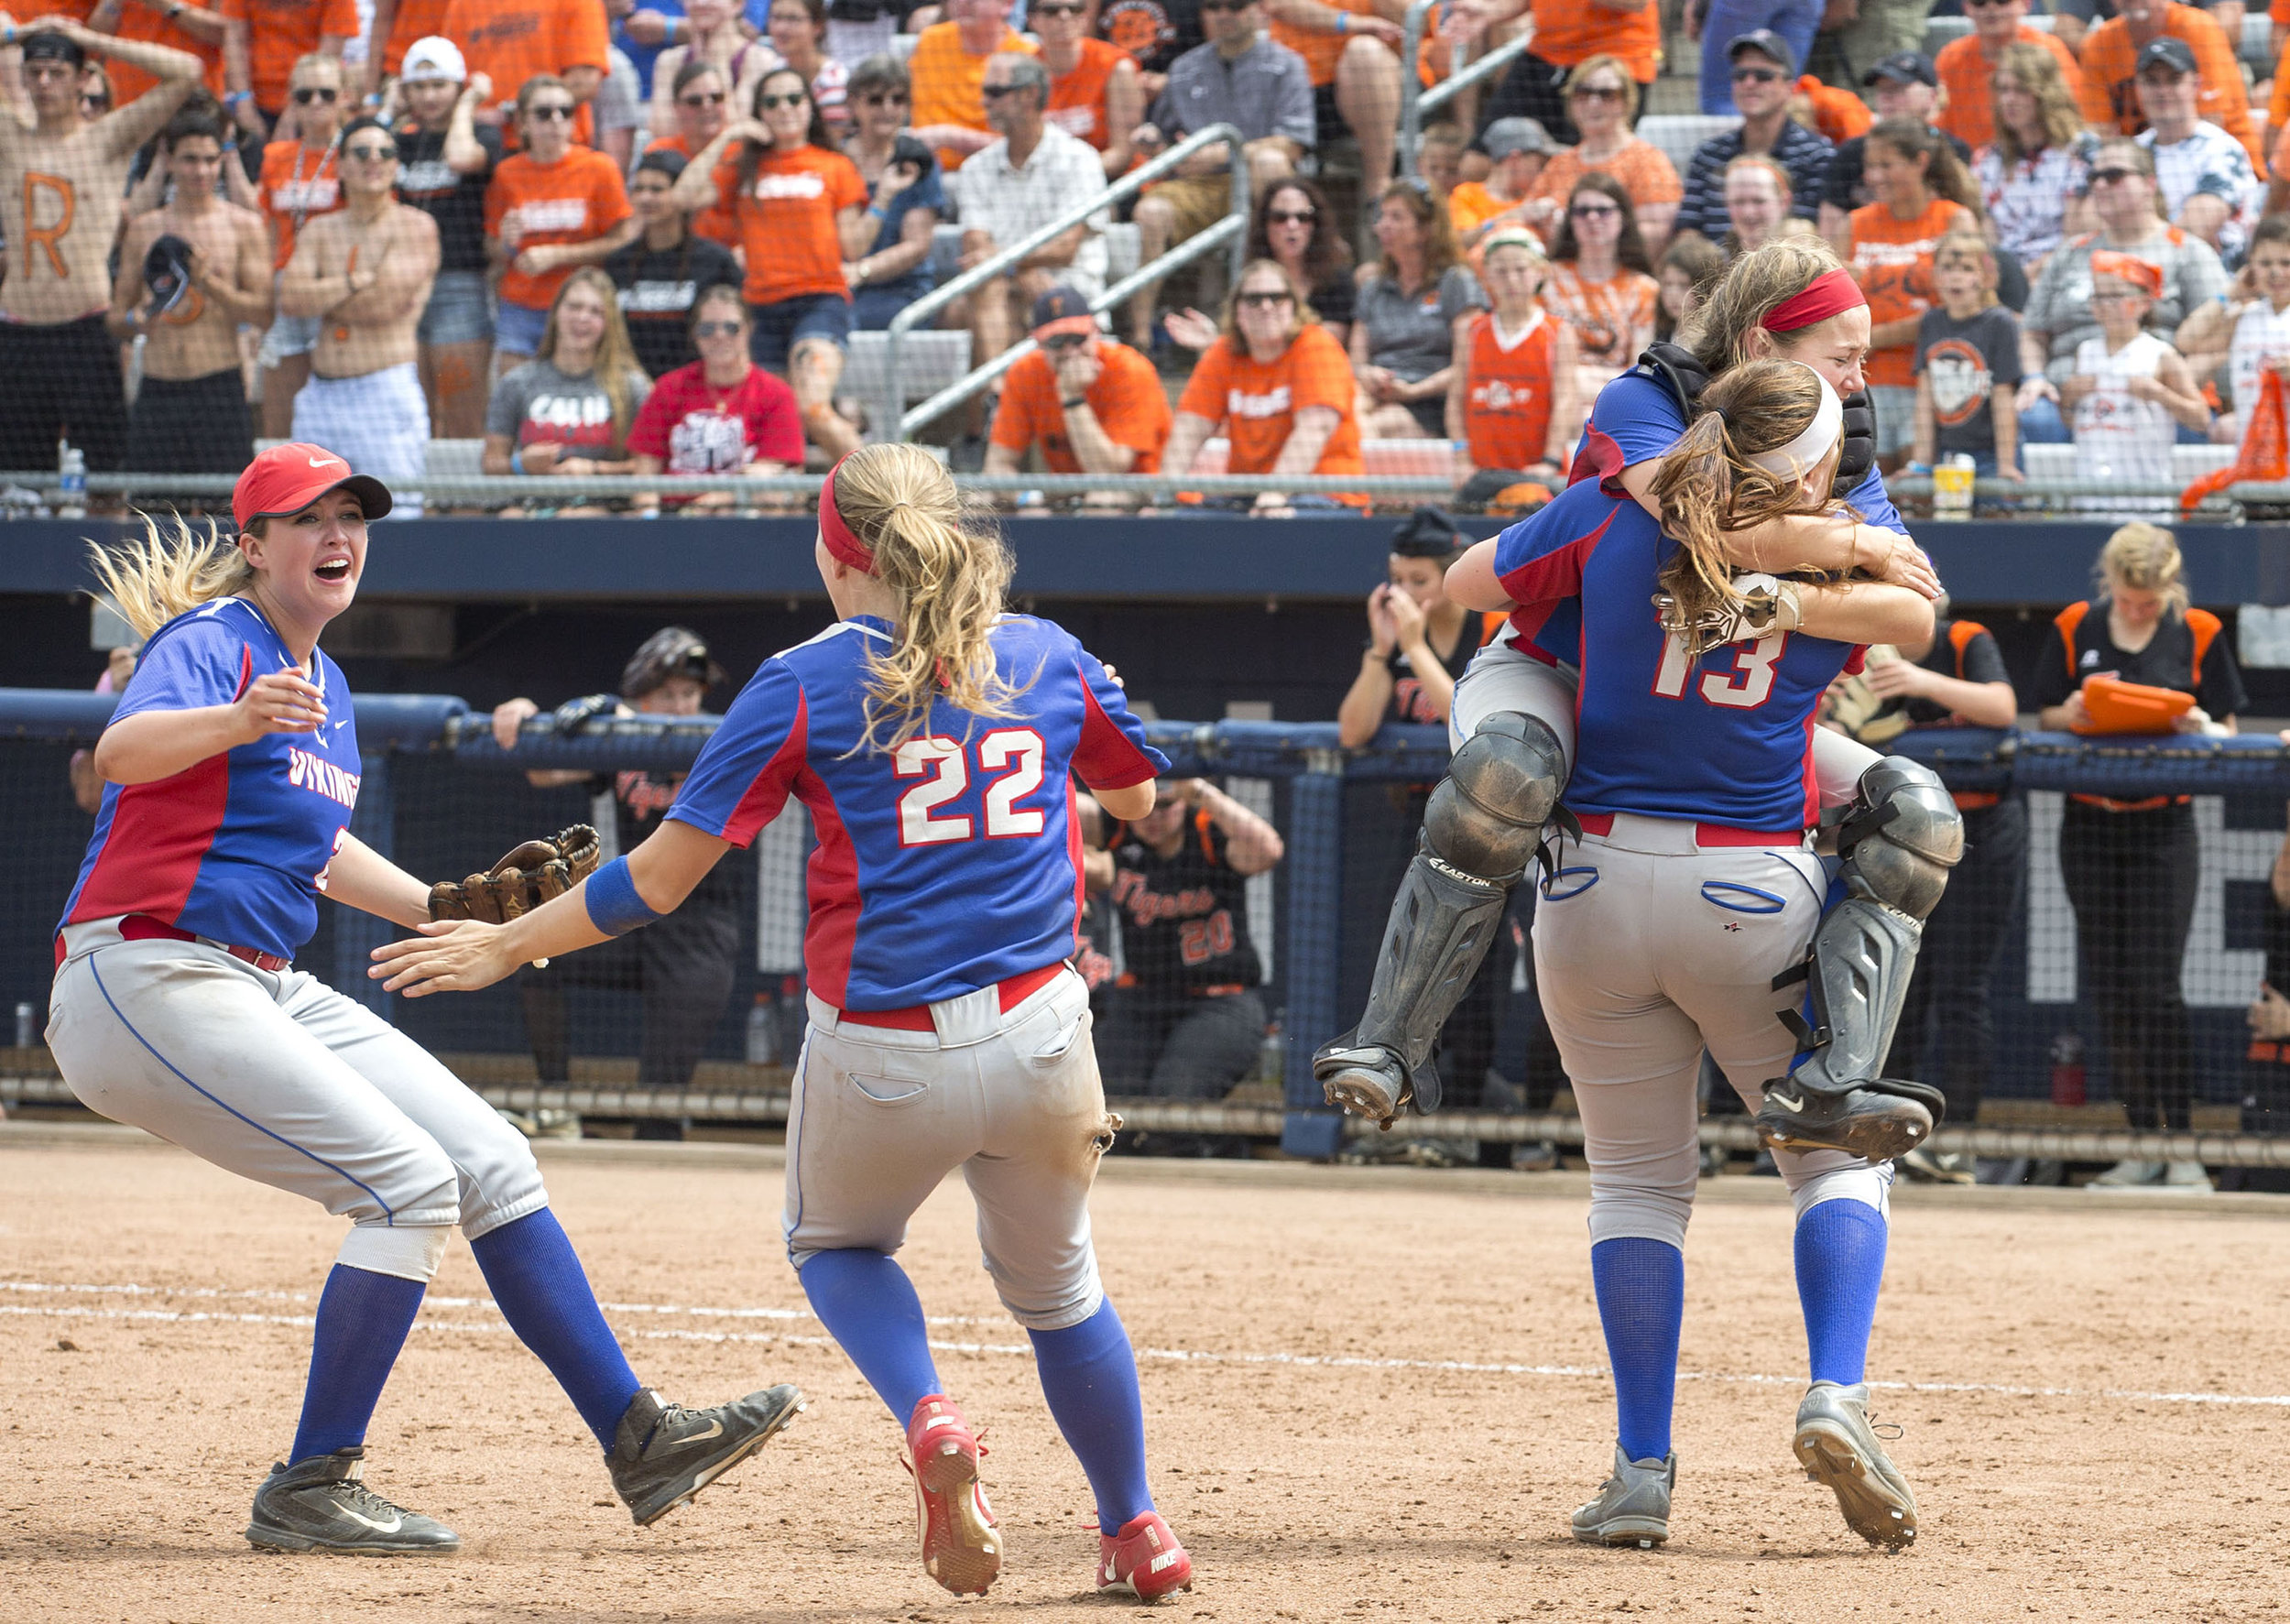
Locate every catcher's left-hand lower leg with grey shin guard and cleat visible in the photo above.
<box><xmin>1313</xmin><ymin>710</ymin><xmax>1566</xmax><ymax>1127</ymax></box>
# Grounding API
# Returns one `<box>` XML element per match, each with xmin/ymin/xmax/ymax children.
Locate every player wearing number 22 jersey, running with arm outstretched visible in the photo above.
<box><xmin>374</xmin><ymin>444</ymin><xmax>1194</xmax><ymax>1601</ymax></box>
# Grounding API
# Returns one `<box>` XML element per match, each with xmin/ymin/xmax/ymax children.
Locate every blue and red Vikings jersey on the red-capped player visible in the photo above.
<box><xmin>58</xmin><ymin>598</ymin><xmax>362</xmax><ymax>957</ymax></box>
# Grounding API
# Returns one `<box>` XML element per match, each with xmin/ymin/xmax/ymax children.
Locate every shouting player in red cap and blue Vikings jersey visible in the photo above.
<box><xmin>49</xmin><ymin>444</ymin><xmax>802</xmax><ymax>1555</ymax></box>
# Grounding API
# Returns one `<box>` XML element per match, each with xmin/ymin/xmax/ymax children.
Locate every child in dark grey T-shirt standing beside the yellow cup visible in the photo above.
<box><xmin>1910</xmin><ymin>232</ymin><xmax>2024</xmax><ymax>479</ymax></box>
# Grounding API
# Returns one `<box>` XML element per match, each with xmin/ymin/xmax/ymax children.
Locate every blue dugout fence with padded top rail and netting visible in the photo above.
<box><xmin>13</xmin><ymin>690</ymin><xmax>2290</xmax><ymax>1166</ymax></box>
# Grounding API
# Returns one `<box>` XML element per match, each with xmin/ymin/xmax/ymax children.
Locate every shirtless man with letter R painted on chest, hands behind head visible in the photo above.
<box><xmin>0</xmin><ymin>12</ymin><xmax>203</xmax><ymax>472</ymax></box>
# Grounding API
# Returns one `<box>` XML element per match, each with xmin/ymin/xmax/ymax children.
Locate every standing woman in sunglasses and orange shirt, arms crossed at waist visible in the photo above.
<box><xmin>485</xmin><ymin>71</ymin><xmax>637</xmax><ymax>365</ymax></box>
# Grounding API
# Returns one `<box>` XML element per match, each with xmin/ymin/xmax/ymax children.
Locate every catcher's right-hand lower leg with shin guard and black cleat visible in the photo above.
<box><xmin>1757</xmin><ymin>756</ymin><xmax>1965</xmax><ymax>1161</ymax></box>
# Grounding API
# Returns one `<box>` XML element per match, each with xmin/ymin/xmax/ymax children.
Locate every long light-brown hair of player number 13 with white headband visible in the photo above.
<box><xmin>1653</xmin><ymin>360</ymin><xmax>1837</xmax><ymax>655</ymax></box>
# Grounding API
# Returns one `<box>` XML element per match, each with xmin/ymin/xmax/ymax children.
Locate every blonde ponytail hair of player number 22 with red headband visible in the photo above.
<box><xmin>836</xmin><ymin>442</ymin><xmax>1024</xmax><ymax>751</ymax></box>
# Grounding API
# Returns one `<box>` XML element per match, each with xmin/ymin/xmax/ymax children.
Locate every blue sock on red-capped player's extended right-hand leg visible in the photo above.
<box><xmin>470</xmin><ymin>1207</ymin><xmax>644</xmax><ymax>1450</ymax></box>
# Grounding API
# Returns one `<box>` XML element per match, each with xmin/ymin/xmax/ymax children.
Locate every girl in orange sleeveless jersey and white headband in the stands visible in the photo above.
<box><xmin>1447</xmin><ymin>227</ymin><xmax>1580</xmax><ymax>490</ymax></box>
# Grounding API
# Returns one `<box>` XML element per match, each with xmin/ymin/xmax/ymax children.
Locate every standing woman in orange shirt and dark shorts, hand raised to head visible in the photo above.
<box><xmin>669</xmin><ymin>69</ymin><xmax>878</xmax><ymax>458</ymax></box>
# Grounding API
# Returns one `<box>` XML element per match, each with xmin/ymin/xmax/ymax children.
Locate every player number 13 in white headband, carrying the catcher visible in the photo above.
<box><xmin>1447</xmin><ymin>362</ymin><xmax>1954</xmax><ymax>1548</ymax></box>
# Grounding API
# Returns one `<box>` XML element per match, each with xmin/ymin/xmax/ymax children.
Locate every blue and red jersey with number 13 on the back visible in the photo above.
<box><xmin>1496</xmin><ymin>484</ymin><xmax>1862</xmax><ymax>832</ymax></box>
